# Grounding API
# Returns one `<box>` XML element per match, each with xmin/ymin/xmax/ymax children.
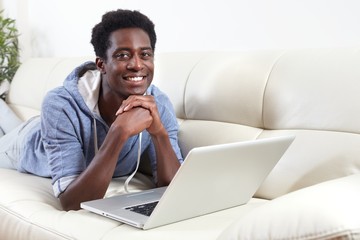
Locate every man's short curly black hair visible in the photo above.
<box><xmin>91</xmin><ymin>9</ymin><xmax>156</xmax><ymax>60</ymax></box>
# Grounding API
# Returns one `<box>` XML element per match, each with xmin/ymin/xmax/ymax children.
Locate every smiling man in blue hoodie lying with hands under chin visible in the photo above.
<box><xmin>0</xmin><ymin>10</ymin><xmax>183</xmax><ymax>210</ymax></box>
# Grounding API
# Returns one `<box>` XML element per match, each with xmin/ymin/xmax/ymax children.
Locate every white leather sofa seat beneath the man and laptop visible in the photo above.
<box><xmin>0</xmin><ymin>168</ymin><xmax>267</xmax><ymax>240</ymax></box>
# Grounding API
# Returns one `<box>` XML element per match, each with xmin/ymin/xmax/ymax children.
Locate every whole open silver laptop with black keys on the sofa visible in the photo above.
<box><xmin>81</xmin><ymin>136</ymin><xmax>294</xmax><ymax>229</ymax></box>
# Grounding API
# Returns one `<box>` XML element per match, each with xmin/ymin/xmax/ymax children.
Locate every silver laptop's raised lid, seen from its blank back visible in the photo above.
<box><xmin>144</xmin><ymin>136</ymin><xmax>294</xmax><ymax>229</ymax></box>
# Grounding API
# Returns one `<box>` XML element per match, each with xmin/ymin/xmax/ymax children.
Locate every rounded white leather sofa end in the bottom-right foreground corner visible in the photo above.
<box><xmin>218</xmin><ymin>174</ymin><xmax>360</xmax><ymax>240</ymax></box>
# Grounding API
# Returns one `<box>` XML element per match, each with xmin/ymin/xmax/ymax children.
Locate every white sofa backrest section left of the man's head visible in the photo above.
<box><xmin>6</xmin><ymin>57</ymin><xmax>94</xmax><ymax>120</ymax></box>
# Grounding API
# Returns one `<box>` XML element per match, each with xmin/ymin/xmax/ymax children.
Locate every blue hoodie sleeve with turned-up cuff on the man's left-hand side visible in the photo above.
<box><xmin>41</xmin><ymin>88</ymin><xmax>91</xmax><ymax>196</ymax></box>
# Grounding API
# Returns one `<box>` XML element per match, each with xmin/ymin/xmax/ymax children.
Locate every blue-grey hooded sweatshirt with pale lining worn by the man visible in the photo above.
<box><xmin>19</xmin><ymin>62</ymin><xmax>183</xmax><ymax>196</ymax></box>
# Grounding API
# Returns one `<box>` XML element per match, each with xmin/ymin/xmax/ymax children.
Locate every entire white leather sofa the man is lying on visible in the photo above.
<box><xmin>0</xmin><ymin>48</ymin><xmax>360</xmax><ymax>240</ymax></box>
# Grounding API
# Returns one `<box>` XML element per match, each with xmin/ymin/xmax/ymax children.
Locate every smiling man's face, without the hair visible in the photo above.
<box><xmin>103</xmin><ymin>28</ymin><xmax>154</xmax><ymax>99</ymax></box>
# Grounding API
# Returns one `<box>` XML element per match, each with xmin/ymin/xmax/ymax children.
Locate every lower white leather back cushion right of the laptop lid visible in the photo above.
<box><xmin>256</xmin><ymin>130</ymin><xmax>360</xmax><ymax>199</ymax></box>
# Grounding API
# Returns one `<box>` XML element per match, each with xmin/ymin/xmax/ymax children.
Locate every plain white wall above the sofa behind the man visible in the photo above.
<box><xmin>0</xmin><ymin>0</ymin><xmax>360</xmax><ymax>59</ymax></box>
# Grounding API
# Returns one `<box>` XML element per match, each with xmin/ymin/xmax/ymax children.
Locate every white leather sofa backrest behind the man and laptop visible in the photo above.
<box><xmin>7</xmin><ymin>48</ymin><xmax>360</xmax><ymax>198</ymax></box>
